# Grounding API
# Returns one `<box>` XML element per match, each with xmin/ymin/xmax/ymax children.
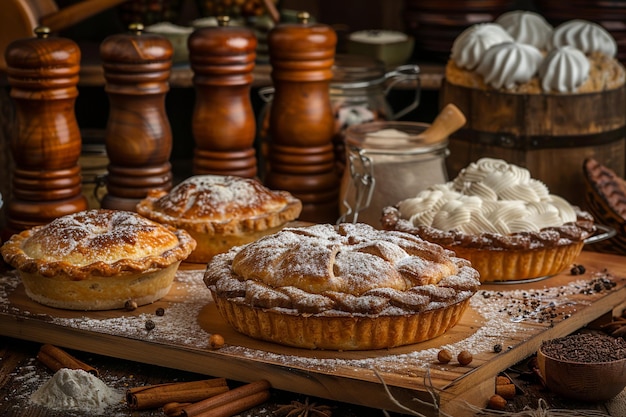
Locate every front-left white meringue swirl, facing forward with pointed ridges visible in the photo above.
<box><xmin>476</xmin><ymin>42</ymin><xmax>543</xmax><ymax>89</ymax></box>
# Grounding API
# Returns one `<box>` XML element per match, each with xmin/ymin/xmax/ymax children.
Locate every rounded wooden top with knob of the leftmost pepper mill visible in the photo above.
<box><xmin>5</xmin><ymin>27</ymin><xmax>80</xmax><ymax>76</ymax></box>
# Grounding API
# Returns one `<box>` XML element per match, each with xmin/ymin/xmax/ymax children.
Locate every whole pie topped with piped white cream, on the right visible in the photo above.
<box><xmin>381</xmin><ymin>158</ymin><xmax>596</xmax><ymax>282</ymax></box>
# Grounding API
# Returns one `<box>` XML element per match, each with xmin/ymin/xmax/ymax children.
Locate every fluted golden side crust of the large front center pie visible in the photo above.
<box><xmin>211</xmin><ymin>290</ymin><xmax>471</xmax><ymax>350</ymax></box>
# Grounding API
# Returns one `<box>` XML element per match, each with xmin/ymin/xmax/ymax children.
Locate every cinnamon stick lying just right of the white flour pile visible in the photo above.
<box><xmin>126</xmin><ymin>378</ymin><xmax>229</xmax><ymax>410</ymax></box>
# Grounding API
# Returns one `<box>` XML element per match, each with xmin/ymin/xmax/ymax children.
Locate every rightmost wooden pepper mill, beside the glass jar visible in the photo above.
<box><xmin>265</xmin><ymin>12</ymin><xmax>339</xmax><ymax>223</ymax></box>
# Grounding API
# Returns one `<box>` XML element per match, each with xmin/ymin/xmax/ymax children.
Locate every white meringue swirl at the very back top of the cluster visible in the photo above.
<box><xmin>495</xmin><ymin>10</ymin><xmax>553</xmax><ymax>50</ymax></box>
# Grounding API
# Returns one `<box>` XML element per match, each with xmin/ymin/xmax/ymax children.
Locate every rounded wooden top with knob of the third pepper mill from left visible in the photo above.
<box><xmin>188</xmin><ymin>16</ymin><xmax>257</xmax><ymax>65</ymax></box>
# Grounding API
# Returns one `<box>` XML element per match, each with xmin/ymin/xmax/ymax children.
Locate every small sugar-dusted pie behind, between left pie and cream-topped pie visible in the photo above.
<box><xmin>137</xmin><ymin>175</ymin><xmax>302</xmax><ymax>263</ymax></box>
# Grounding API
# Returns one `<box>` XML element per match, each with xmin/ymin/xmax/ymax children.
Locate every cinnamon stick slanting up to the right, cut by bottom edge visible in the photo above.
<box><xmin>182</xmin><ymin>379</ymin><xmax>270</xmax><ymax>417</ymax></box>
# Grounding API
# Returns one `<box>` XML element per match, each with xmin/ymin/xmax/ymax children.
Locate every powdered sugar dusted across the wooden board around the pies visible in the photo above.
<box><xmin>0</xmin><ymin>264</ymin><xmax>614</xmax><ymax>376</ymax></box>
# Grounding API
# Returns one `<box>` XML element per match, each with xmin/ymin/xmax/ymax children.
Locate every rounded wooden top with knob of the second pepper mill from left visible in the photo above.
<box><xmin>100</xmin><ymin>23</ymin><xmax>174</xmax><ymax>66</ymax></box>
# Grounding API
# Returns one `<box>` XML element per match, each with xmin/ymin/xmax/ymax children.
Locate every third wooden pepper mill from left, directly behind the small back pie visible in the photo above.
<box><xmin>188</xmin><ymin>16</ymin><xmax>257</xmax><ymax>178</ymax></box>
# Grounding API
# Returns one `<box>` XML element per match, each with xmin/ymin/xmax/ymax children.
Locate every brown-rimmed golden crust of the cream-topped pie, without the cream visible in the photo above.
<box><xmin>381</xmin><ymin>207</ymin><xmax>595</xmax><ymax>282</ymax></box>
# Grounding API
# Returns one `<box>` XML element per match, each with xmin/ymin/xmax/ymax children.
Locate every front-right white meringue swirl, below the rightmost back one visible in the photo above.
<box><xmin>539</xmin><ymin>46</ymin><xmax>591</xmax><ymax>93</ymax></box>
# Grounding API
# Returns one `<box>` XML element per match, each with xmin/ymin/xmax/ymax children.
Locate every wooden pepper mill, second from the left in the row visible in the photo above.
<box><xmin>100</xmin><ymin>23</ymin><xmax>173</xmax><ymax>211</ymax></box>
